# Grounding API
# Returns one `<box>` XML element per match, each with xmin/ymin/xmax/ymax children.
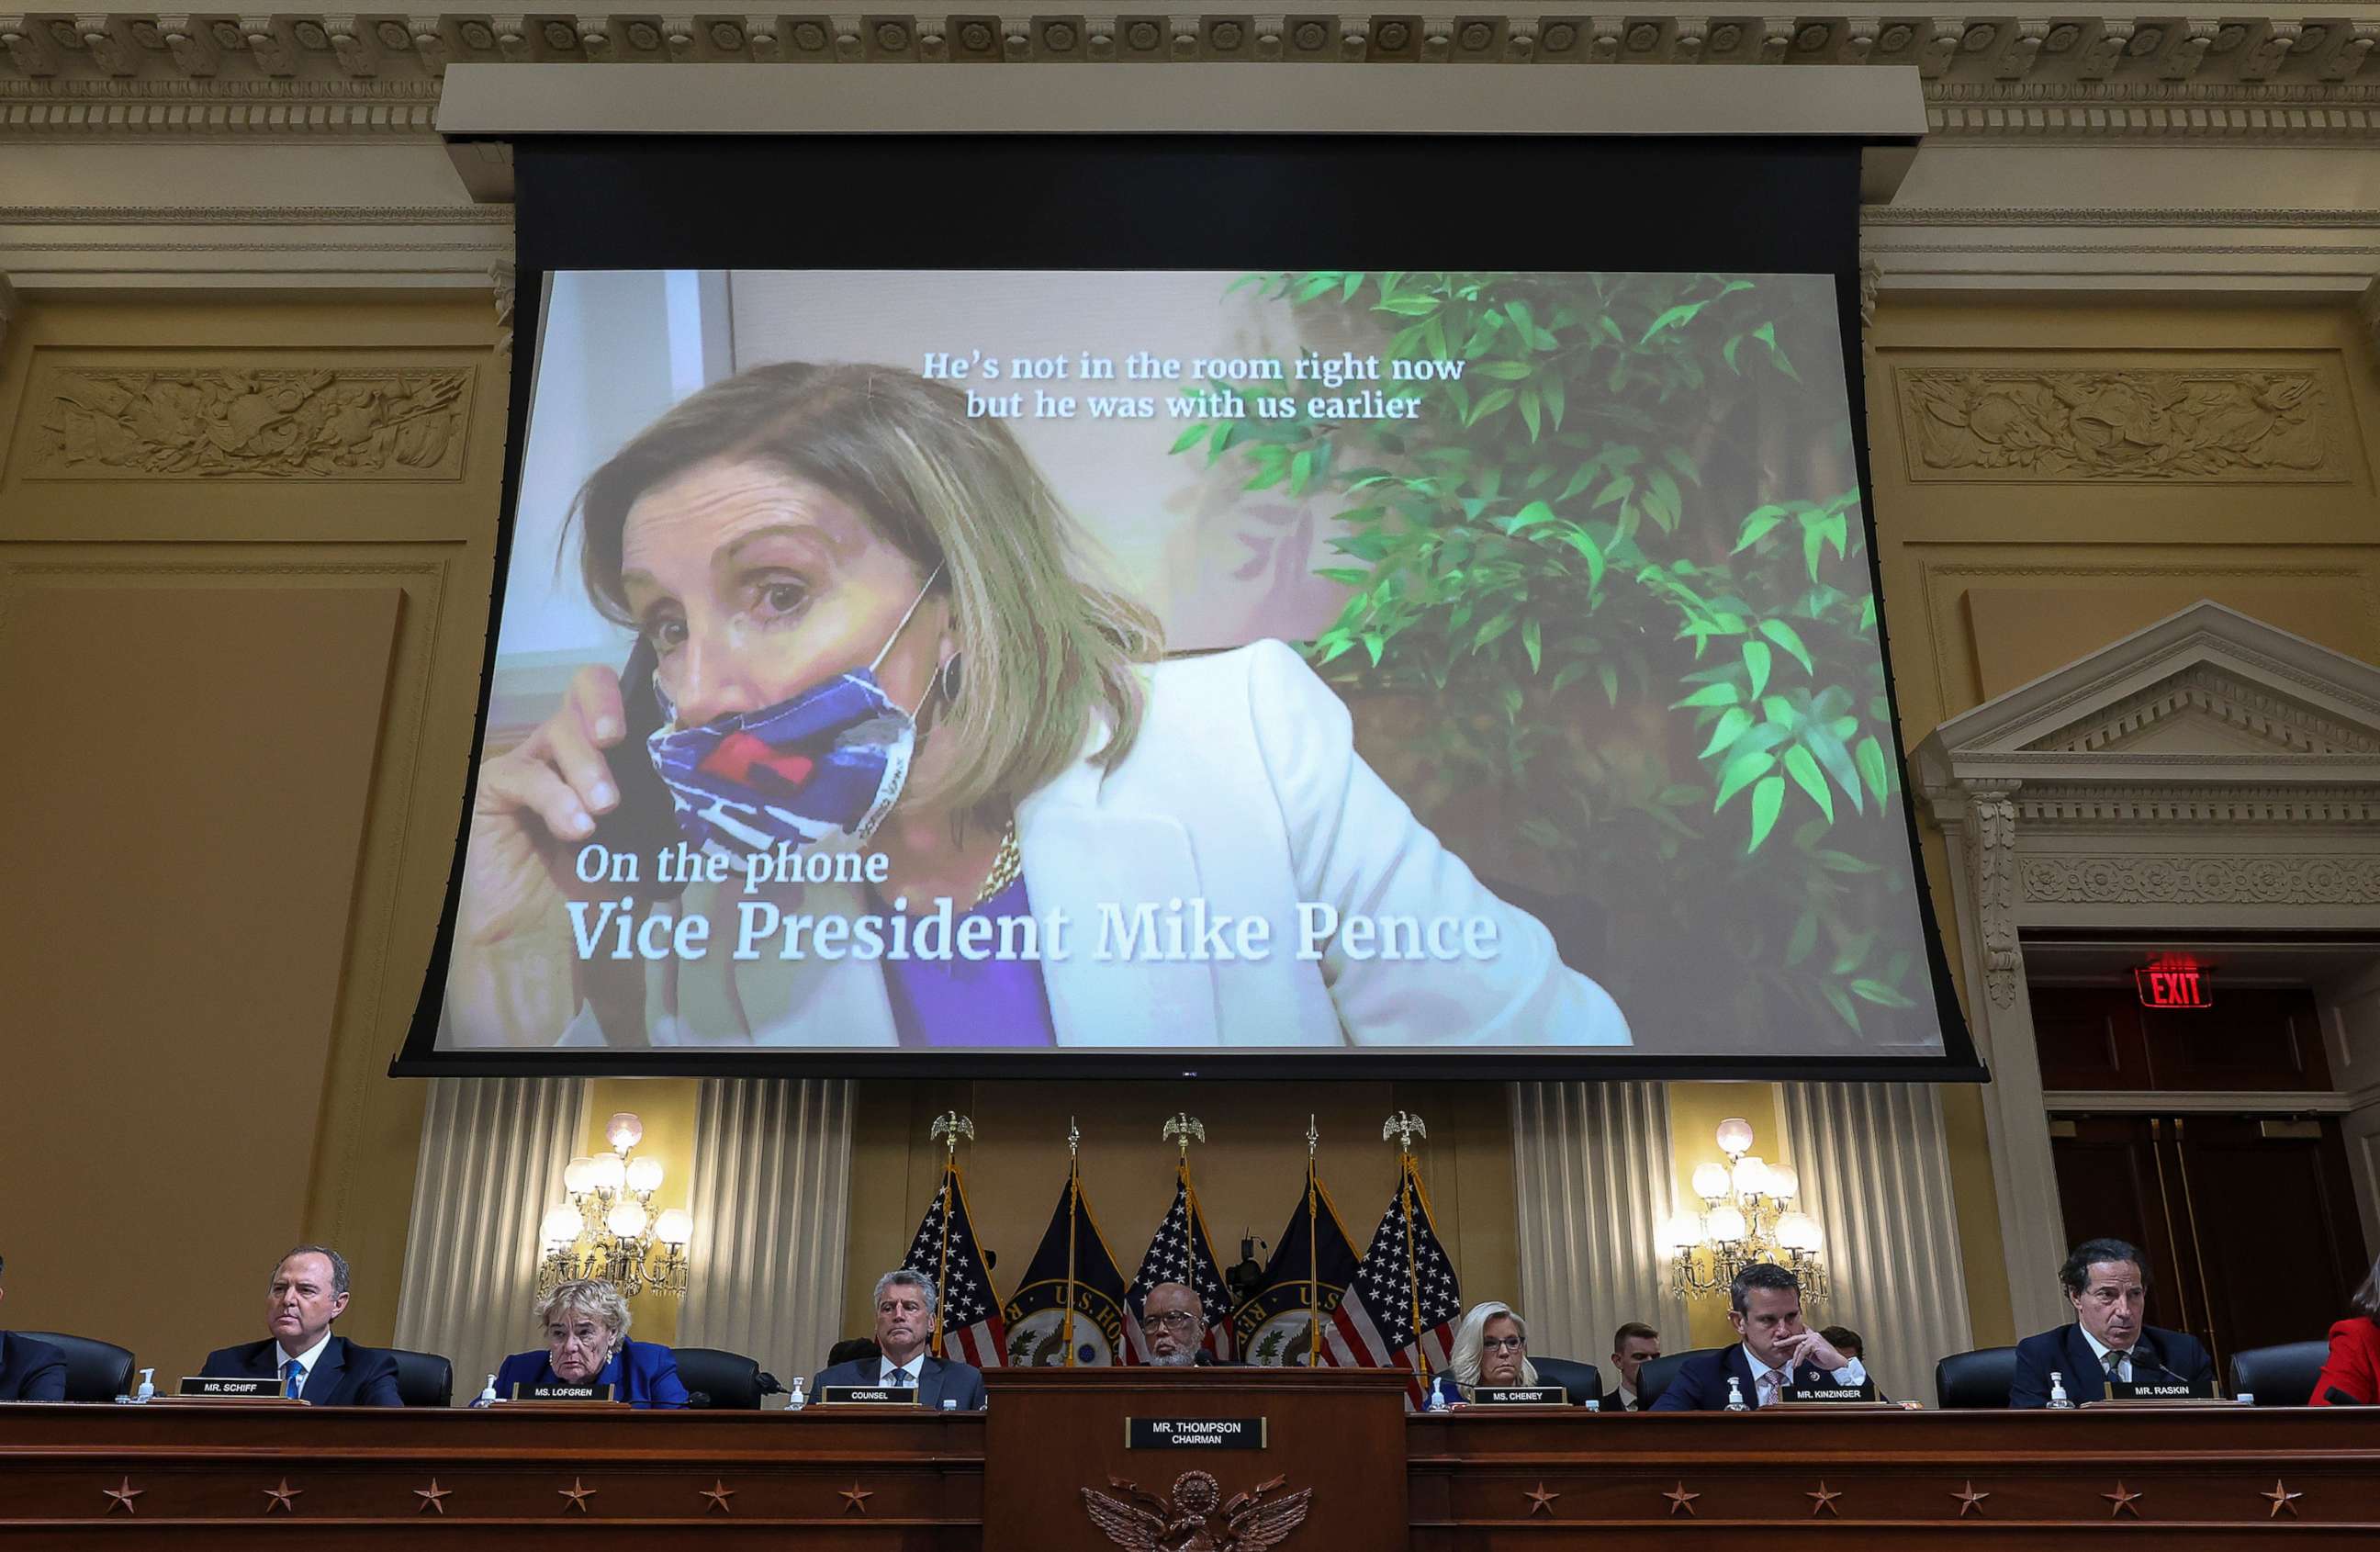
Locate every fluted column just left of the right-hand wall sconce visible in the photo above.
<box><xmin>1513</xmin><ymin>1083</ymin><xmax>1685</xmax><ymax>1383</ymax></box>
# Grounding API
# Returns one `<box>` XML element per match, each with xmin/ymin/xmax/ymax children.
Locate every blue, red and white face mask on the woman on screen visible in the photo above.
<box><xmin>645</xmin><ymin>567</ymin><xmax>942</xmax><ymax>861</ymax></box>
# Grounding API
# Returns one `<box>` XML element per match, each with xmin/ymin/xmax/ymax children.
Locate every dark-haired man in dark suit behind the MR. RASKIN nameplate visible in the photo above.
<box><xmin>2009</xmin><ymin>1240</ymin><xmax>2216</xmax><ymax>1407</ymax></box>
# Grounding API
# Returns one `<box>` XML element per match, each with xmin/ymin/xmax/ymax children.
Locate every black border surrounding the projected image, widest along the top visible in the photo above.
<box><xmin>387</xmin><ymin>136</ymin><xmax>1990</xmax><ymax>1083</ymax></box>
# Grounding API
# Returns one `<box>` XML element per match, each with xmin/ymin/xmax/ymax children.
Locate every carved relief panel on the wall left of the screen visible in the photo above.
<box><xmin>17</xmin><ymin>362</ymin><xmax>471</xmax><ymax>481</ymax></box>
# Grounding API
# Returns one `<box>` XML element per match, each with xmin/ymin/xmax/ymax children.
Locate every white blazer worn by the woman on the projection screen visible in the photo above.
<box><xmin>604</xmin><ymin>640</ymin><xmax>1628</xmax><ymax>1050</ymax></box>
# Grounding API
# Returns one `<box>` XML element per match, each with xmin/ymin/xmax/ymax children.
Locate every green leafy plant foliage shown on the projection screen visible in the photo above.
<box><xmin>1173</xmin><ymin>271</ymin><xmax>1923</xmax><ymax>1050</ymax></box>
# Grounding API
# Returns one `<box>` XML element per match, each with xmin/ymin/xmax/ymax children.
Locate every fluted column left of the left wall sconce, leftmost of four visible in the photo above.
<box><xmin>398</xmin><ymin>1078</ymin><xmax>586</xmax><ymax>1402</ymax></box>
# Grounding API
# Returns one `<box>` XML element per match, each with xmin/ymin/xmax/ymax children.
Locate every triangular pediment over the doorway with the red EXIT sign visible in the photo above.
<box><xmin>1916</xmin><ymin>600</ymin><xmax>2380</xmax><ymax>794</ymax></box>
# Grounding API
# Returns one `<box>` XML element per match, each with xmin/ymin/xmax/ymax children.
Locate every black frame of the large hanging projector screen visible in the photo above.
<box><xmin>390</xmin><ymin>136</ymin><xmax>1990</xmax><ymax>1083</ymax></box>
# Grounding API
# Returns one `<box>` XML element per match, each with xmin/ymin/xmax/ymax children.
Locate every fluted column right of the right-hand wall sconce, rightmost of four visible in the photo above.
<box><xmin>1778</xmin><ymin>1083</ymin><xmax>1975</xmax><ymax>1407</ymax></box>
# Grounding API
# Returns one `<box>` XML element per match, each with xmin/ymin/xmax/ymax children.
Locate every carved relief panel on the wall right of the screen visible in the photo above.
<box><xmin>1892</xmin><ymin>353</ymin><xmax>2353</xmax><ymax>486</ymax></box>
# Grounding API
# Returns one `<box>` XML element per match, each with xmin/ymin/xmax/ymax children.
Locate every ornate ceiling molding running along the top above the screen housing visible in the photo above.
<box><xmin>0</xmin><ymin>3</ymin><xmax>2380</xmax><ymax>145</ymax></box>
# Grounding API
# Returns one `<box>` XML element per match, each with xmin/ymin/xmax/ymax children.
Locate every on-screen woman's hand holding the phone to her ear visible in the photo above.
<box><xmin>455</xmin><ymin>664</ymin><xmax>628</xmax><ymax>948</ymax></box>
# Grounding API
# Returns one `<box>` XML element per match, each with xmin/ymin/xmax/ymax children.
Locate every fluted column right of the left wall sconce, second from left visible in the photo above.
<box><xmin>679</xmin><ymin>1078</ymin><xmax>852</xmax><ymax>1383</ymax></box>
